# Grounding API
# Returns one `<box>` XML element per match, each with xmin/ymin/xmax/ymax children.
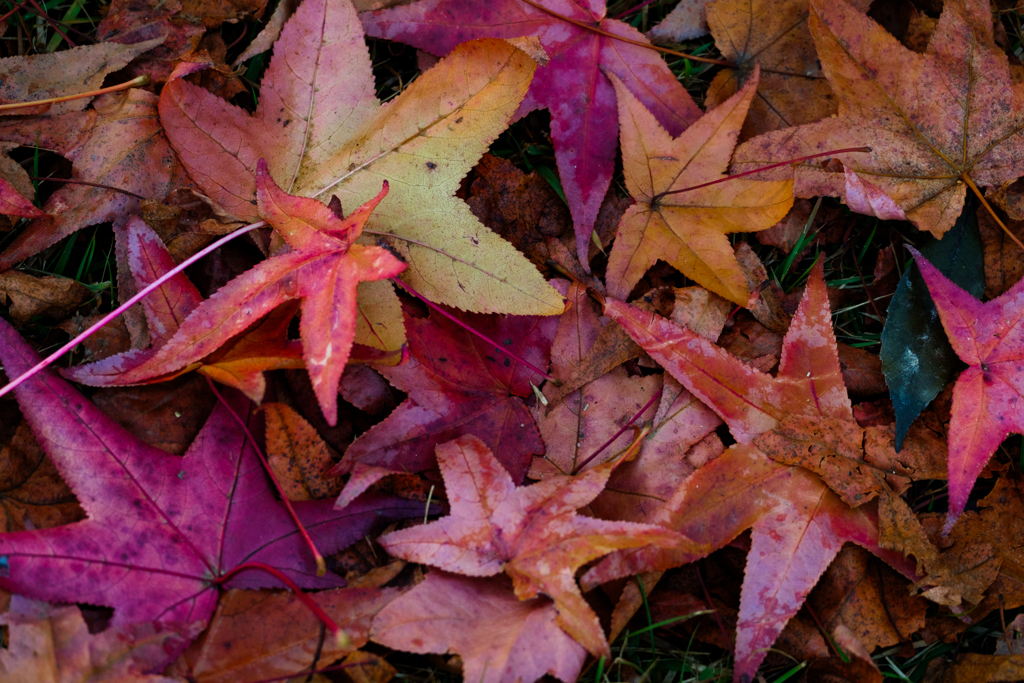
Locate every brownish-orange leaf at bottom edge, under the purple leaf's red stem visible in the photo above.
<box><xmin>191</xmin><ymin>588</ymin><xmax>400</xmax><ymax>683</ymax></box>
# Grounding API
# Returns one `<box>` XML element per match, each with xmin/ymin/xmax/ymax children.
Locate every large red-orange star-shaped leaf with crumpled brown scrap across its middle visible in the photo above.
<box><xmin>584</xmin><ymin>262</ymin><xmax>914</xmax><ymax>681</ymax></box>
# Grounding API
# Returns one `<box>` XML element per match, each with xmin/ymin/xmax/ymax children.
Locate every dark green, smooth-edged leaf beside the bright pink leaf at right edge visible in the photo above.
<box><xmin>879</xmin><ymin>201</ymin><xmax>985</xmax><ymax>452</ymax></box>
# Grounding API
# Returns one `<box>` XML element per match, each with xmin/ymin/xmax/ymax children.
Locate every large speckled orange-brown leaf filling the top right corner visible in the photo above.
<box><xmin>734</xmin><ymin>0</ymin><xmax>1024</xmax><ymax>238</ymax></box>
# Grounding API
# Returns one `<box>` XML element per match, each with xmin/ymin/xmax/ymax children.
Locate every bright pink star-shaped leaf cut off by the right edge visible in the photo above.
<box><xmin>910</xmin><ymin>248</ymin><xmax>1024</xmax><ymax>535</ymax></box>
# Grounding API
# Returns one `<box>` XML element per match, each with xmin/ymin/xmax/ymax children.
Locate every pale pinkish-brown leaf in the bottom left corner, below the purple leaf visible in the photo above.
<box><xmin>0</xmin><ymin>595</ymin><xmax>203</xmax><ymax>683</ymax></box>
